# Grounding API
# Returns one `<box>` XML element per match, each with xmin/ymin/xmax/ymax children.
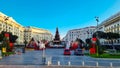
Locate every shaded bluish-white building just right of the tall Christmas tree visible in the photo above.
<box><xmin>63</xmin><ymin>26</ymin><xmax>96</xmax><ymax>42</ymax></box>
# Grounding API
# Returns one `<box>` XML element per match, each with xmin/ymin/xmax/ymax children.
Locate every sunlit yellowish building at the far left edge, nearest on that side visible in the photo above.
<box><xmin>0</xmin><ymin>12</ymin><xmax>24</xmax><ymax>44</ymax></box>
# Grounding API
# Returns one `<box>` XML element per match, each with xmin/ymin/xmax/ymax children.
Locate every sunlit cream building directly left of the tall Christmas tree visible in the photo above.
<box><xmin>24</xmin><ymin>26</ymin><xmax>53</xmax><ymax>42</ymax></box>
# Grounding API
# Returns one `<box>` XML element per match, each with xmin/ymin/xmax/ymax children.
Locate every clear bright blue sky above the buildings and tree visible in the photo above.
<box><xmin>0</xmin><ymin>0</ymin><xmax>120</xmax><ymax>37</ymax></box>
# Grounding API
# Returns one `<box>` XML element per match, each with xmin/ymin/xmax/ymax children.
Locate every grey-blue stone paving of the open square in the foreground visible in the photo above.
<box><xmin>0</xmin><ymin>49</ymin><xmax>120</xmax><ymax>68</ymax></box>
